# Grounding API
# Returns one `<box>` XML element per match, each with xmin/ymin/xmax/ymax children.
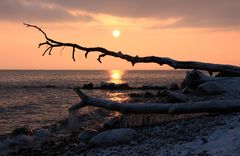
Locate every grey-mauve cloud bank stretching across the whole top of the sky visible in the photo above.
<box><xmin>0</xmin><ymin>0</ymin><xmax>240</xmax><ymax>28</ymax></box>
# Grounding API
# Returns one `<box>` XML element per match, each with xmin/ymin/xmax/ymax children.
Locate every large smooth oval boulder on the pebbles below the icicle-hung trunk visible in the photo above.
<box><xmin>88</xmin><ymin>128</ymin><xmax>137</xmax><ymax>147</ymax></box>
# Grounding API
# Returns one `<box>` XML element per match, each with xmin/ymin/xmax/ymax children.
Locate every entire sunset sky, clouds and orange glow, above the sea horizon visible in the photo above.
<box><xmin>0</xmin><ymin>0</ymin><xmax>240</xmax><ymax>70</ymax></box>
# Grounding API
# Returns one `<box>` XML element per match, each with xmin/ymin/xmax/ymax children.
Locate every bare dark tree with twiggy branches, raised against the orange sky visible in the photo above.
<box><xmin>24</xmin><ymin>23</ymin><xmax>240</xmax><ymax>75</ymax></box>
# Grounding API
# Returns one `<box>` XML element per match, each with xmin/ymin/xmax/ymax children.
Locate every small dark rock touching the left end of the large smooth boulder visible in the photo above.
<box><xmin>78</xmin><ymin>130</ymin><xmax>98</xmax><ymax>144</ymax></box>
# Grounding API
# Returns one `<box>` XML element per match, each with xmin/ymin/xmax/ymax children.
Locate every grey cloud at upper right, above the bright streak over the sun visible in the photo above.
<box><xmin>53</xmin><ymin>0</ymin><xmax>240</xmax><ymax>27</ymax></box>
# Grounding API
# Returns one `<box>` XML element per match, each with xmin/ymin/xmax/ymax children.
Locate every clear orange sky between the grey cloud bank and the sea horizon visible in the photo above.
<box><xmin>0</xmin><ymin>0</ymin><xmax>240</xmax><ymax>70</ymax></box>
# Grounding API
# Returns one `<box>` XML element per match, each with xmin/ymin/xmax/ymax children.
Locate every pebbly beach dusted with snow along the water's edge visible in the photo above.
<box><xmin>0</xmin><ymin>75</ymin><xmax>240</xmax><ymax>156</ymax></box>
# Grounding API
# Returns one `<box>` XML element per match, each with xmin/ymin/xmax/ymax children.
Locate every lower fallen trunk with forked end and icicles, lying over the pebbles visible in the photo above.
<box><xmin>69</xmin><ymin>88</ymin><xmax>240</xmax><ymax>114</ymax></box>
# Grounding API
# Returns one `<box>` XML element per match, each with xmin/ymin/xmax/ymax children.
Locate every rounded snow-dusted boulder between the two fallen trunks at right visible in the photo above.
<box><xmin>197</xmin><ymin>82</ymin><xmax>225</xmax><ymax>95</ymax></box>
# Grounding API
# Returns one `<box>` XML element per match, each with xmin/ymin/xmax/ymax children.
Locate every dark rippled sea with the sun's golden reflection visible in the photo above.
<box><xmin>0</xmin><ymin>70</ymin><xmax>185</xmax><ymax>134</ymax></box>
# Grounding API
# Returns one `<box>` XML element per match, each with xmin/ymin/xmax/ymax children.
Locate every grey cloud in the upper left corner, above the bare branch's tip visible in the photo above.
<box><xmin>0</xmin><ymin>0</ymin><xmax>92</xmax><ymax>22</ymax></box>
